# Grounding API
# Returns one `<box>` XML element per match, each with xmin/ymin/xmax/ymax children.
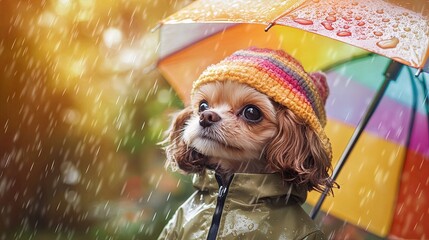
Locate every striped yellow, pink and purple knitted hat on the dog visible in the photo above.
<box><xmin>192</xmin><ymin>47</ymin><xmax>332</xmax><ymax>158</ymax></box>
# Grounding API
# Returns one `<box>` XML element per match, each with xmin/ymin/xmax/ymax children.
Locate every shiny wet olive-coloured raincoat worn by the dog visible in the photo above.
<box><xmin>159</xmin><ymin>170</ymin><xmax>325</xmax><ymax>240</ymax></box>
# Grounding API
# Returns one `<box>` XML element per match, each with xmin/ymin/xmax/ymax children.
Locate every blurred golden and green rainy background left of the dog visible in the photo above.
<box><xmin>0</xmin><ymin>0</ymin><xmax>192</xmax><ymax>239</ymax></box>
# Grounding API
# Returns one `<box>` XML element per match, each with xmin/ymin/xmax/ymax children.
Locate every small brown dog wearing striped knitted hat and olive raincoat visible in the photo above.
<box><xmin>160</xmin><ymin>48</ymin><xmax>332</xmax><ymax>239</ymax></box>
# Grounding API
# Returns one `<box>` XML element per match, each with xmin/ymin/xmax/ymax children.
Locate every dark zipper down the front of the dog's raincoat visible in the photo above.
<box><xmin>207</xmin><ymin>174</ymin><xmax>233</xmax><ymax>240</ymax></box>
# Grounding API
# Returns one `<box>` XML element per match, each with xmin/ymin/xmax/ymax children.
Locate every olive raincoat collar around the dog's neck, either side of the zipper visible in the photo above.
<box><xmin>192</xmin><ymin>170</ymin><xmax>307</xmax><ymax>204</ymax></box>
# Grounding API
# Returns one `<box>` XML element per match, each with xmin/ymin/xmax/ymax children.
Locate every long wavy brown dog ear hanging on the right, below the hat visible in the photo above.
<box><xmin>264</xmin><ymin>107</ymin><xmax>332</xmax><ymax>191</ymax></box>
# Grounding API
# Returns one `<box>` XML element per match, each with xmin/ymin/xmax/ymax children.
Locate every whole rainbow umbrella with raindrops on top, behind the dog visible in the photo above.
<box><xmin>154</xmin><ymin>0</ymin><xmax>429</xmax><ymax>238</ymax></box>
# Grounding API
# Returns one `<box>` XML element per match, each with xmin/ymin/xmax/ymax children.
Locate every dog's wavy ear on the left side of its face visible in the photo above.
<box><xmin>162</xmin><ymin>107</ymin><xmax>205</xmax><ymax>173</ymax></box>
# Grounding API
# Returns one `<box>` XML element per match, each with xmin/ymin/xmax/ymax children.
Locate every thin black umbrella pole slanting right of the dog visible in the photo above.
<box><xmin>310</xmin><ymin>60</ymin><xmax>403</xmax><ymax>219</ymax></box>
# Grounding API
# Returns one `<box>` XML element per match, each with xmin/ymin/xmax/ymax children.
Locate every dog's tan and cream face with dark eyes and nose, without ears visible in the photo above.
<box><xmin>183</xmin><ymin>81</ymin><xmax>277</xmax><ymax>169</ymax></box>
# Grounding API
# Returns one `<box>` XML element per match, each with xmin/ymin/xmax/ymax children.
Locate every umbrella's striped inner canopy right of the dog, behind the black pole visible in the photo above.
<box><xmin>308</xmin><ymin>55</ymin><xmax>429</xmax><ymax>239</ymax></box>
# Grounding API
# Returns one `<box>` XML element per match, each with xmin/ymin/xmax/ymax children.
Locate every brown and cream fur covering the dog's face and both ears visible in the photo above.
<box><xmin>165</xmin><ymin>81</ymin><xmax>332</xmax><ymax>191</ymax></box>
